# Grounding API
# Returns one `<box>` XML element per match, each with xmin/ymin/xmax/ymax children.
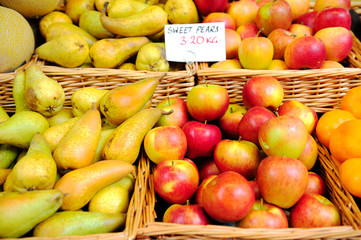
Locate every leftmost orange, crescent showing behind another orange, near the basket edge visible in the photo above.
<box><xmin>316</xmin><ymin>109</ymin><xmax>356</xmax><ymax>147</ymax></box>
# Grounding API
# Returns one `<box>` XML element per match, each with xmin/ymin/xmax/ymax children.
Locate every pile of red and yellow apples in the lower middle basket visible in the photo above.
<box><xmin>143</xmin><ymin>76</ymin><xmax>341</xmax><ymax>228</ymax></box>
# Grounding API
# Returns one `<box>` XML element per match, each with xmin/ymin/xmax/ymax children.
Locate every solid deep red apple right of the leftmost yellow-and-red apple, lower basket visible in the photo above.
<box><xmin>182</xmin><ymin>121</ymin><xmax>222</xmax><ymax>159</ymax></box>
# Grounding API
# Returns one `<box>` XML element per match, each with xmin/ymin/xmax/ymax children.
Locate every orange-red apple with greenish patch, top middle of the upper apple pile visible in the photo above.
<box><xmin>255</xmin><ymin>0</ymin><xmax>292</xmax><ymax>36</ymax></box>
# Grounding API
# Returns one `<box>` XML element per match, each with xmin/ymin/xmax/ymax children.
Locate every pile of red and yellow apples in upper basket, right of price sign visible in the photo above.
<box><xmin>195</xmin><ymin>0</ymin><xmax>353</xmax><ymax>70</ymax></box>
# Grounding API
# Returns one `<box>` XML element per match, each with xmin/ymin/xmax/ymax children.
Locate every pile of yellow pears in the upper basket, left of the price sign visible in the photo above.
<box><xmin>35</xmin><ymin>0</ymin><xmax>200</xmax><ymax>72</ymax></box>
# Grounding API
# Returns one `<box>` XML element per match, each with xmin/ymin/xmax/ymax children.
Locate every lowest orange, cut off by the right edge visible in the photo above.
<box><xmin>339</xmin><ymin>158</ymin><xmax>361</xmax><ymax>197</ymax></box>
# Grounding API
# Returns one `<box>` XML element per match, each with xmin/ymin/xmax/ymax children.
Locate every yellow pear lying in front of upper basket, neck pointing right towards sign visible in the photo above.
<box><xmin>89</xmin><ymin>37</ymin><xmax>150</xmax><ymax>68</ymax></box>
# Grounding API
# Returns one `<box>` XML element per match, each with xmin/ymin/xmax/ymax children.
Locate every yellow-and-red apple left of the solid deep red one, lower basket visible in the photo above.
<box><xmin>143</xmin><ymin>126</ymin><xmax>187</xmax><ymax>164</ymax></box>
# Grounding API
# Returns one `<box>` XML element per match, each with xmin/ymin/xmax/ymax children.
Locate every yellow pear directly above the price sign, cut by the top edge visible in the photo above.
<box><xmin>164</xmin><ymin>0</ymin><xmax>199</xmax><ymax>24</ymax></box>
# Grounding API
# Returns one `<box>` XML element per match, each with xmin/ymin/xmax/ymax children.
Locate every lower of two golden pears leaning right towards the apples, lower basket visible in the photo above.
<box><xmin>103</xmin><ymin>108</ymin><xmax>163</xmax><ymax>164</ymax></box>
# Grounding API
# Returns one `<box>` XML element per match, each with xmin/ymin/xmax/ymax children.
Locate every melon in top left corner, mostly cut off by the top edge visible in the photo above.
<box><xmin>0</xmin><ymin>0</ymin><xmax>60</xmax><ymax>18</ymax></box>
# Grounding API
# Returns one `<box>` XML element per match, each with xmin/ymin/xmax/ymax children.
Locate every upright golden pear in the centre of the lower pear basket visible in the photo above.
<box><xmin>53</xmin><ymin>103</ymin><xmax>102</xmax><ymax>172</ymax></box>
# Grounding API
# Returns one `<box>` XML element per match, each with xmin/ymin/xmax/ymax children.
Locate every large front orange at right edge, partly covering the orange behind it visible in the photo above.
<box><xmin>329</xmin><ymin>119</ymin><xmax>361</xmax><ymax>164</ymax></box>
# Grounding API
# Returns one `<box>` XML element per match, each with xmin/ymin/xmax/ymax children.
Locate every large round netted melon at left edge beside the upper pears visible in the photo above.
<box><xmin>0</xmin><ymin>6</ymin><xmax>35</xmax><ymax>72</ymax></box>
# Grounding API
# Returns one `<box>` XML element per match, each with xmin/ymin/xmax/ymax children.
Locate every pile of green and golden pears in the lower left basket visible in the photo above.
<box><xmin>0</xmin><ymin>62</ymin><xmax>165</xmax><ymax>238</ymax></box>
